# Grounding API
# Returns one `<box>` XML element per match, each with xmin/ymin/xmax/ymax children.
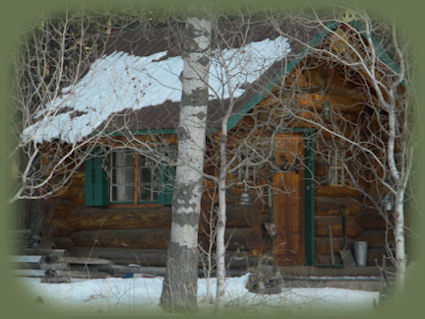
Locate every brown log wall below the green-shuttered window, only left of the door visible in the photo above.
<box><xmin>47</xmin><ymin>168</ymin><xmax>264</xmax><ymax>266</ymax></box>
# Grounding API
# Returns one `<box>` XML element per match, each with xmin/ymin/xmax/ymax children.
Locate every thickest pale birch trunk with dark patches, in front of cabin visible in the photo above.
<box><xmin>160</xmin><ymin>18</ymin><xmax>211</xmax><ymax>312</ymax></box>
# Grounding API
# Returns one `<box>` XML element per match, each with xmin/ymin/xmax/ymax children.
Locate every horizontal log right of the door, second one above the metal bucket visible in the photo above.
<box><xmin>314</xmin><ymin>194</ymin><xmax>362</xmax><ymax>216</ymax></box>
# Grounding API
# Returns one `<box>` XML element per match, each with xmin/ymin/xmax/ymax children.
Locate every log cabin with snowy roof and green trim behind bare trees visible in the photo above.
<box><xmin>24</xmin><ymin>18</ymin><xmax>400</xmax><ymax>267</ymax></box>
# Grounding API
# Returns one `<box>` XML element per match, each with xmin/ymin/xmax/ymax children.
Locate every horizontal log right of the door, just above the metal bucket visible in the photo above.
<box><xmin>315</xmin><ymin>216</ymin><xmax>363</xmax><ymax>238</ymax></box>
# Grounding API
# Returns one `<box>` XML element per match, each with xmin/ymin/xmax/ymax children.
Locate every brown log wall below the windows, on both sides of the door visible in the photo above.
<box><xmin>45</xmin><ymin>166</ymin><xmax>385</xmax><ymax>265</ymax></box>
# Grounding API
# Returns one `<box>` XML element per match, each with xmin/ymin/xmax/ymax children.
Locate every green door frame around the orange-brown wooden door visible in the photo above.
<box><xmin>270</xmin><ymin>127</ymin><xmax>316</xmax><ymax>266</ymax></box>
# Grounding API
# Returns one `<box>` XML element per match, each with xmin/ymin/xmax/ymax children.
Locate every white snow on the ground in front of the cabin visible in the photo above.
<box><xmin>19</xmin><ymin>275</ymin><xmax>379</xmax><ymax>314</ymax></box>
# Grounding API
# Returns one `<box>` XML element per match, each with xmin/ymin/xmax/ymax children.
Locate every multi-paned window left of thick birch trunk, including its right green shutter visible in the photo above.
<box><xmin>109</xmin><ymin>146</ymin><xmax>175</xmax><ymax>204</ymax></box>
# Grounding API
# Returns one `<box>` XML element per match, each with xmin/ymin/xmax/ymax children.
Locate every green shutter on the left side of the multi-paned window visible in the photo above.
<box><xmin>84</xmin><ymin>157</ymin><xmax>108</xmax><ymax>206</ymax></box>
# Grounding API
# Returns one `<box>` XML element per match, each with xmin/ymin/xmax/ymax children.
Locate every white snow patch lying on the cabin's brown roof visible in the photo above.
<box><xmin>23</xmin><ymin>36</ymin><xmax>290</xmax><ymax>143</ymax></box>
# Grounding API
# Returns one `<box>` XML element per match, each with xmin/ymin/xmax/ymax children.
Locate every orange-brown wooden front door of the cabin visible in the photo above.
<box><xmin>273</xmin><ymin>134</ymin><xmax>305</xmax><ymax>265</ymax></box>
